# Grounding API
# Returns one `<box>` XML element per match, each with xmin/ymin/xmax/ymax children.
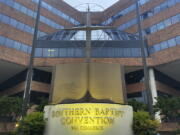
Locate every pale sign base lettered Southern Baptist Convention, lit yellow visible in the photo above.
<box><xmin>44</xmin><ymin>103</ymin><xmax>133</xmax><ymax>135</ymax></box>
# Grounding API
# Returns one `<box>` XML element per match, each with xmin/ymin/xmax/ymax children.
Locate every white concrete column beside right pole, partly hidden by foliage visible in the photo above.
<box><xmin>149</xmin><ymin>68</ymin><xmax>161</xmax><ymax>122</ymax></box>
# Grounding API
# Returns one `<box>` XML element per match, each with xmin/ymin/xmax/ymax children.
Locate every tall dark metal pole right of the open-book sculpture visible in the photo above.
<box><xmin>135</xmin><ymin>0</ymin><xmax>153</xmax><ymax>115</ymax></box>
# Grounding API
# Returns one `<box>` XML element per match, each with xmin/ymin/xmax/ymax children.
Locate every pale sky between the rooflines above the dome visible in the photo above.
<box><xmin>64</xmin><ymin>0</ymin><xmax>118</xmax><ymax>10</ymax></box>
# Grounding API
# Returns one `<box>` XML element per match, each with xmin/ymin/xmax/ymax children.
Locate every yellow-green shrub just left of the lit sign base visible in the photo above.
<box><xmin>15</xmin><ymin>112</ymin><xmax>45</xmax><ymax>135</ymax></box>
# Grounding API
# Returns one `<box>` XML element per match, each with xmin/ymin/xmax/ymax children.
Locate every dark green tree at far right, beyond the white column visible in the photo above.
<box><xmin>154</xmin><ymin>97</ymin><xmax>180</xmax><ymax>122</ymax></box>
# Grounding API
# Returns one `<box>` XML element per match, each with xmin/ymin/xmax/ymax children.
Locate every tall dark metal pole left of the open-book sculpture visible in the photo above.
<box><xmin>21</xmin><ymin>0</ymin><xmax>42</xmax><ymax>117</ymax></box>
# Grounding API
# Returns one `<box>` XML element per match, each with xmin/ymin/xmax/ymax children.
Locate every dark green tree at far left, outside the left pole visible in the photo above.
<box><xmin>0</xmin><ymin>96</ymin><xmax>22</xmax><ymax>132</ymax></box>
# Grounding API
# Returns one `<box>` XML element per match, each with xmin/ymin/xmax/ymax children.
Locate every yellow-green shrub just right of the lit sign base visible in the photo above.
<box><xmin>133</xmin><ymin>111</ymin><xmax>159</xmax><ymax>135</ymax></box>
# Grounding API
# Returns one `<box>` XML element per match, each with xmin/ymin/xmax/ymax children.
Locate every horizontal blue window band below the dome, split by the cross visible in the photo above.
<box><xmin>35</xmin><ymin>47</ymin><xmax>141</xmax><ymax>58</ymax></box>
